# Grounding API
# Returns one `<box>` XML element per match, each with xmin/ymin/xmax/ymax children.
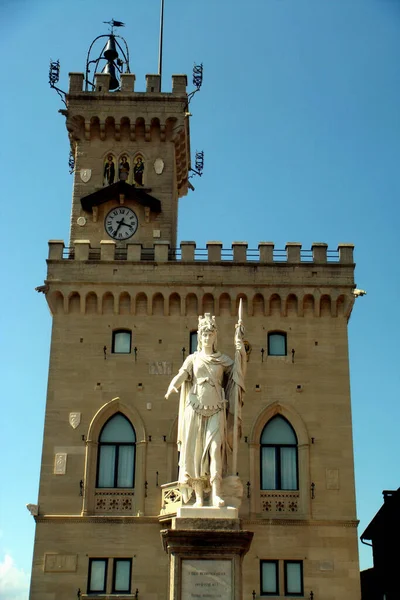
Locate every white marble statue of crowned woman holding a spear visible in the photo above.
<box><xmin>165</xmin><ymin>313</ymin><xmax>246</xmax><ymax>507</ymax></box>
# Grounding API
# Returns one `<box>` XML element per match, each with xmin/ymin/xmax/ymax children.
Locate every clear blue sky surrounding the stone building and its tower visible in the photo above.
<box><xmin>0</xmin><ymin>0</ymin><xmax>400</xmax><ymax>600</ymax></box>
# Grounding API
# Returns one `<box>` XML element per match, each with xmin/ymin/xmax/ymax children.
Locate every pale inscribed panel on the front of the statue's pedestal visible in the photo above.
<box><xmin>181</xmin><ymin>558</ymin><xmax>233</xmax><ymax>600</ymax></box>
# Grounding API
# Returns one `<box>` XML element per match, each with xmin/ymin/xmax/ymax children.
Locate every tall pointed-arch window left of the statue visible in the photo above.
<box><xmin>97</xmin><ymin>413</ymin><xmax>136</xmax><ymax>488</ymax></box>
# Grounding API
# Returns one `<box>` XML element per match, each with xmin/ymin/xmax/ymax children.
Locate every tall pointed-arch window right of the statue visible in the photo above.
<box><xmin>260</xmin><ymin>415</ymin><xmax>299</xmax><ymax>490</ymax></box>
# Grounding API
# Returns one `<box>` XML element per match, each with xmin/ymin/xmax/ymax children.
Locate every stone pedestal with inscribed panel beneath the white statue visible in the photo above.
<box><xmin>161</xmin><ymin>507</ymin><xmax>253</xmax><ymax>600</ymax></box>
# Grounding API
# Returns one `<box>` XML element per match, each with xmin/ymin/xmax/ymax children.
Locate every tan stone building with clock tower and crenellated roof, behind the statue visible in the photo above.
<box><xmin>30</xmin><ymin>38</ymin><xmax>360</xmax><ymax>600</ymax></box>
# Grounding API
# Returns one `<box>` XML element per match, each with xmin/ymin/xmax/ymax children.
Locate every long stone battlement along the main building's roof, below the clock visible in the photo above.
<box><xmin>48</xmin><ymin>240</ymin><xmax>354</xmax><ymax>265</ymax></box>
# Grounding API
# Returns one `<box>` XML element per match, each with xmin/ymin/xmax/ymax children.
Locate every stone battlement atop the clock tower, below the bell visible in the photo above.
<box><xmin>68</xmin><ymin>73</ymin><xmax>187</xmax><ymax>99</ymax></box>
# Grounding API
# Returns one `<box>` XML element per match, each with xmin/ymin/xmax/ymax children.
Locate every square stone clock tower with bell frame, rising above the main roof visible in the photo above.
<box><xmin>62</xmin><ymin>27</ymin><xmax>190</xmax><ymax>253</ymax></box>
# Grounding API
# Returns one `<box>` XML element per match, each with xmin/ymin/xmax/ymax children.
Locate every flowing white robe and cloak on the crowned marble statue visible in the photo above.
<box><xmin>178</xmin><ymin>351</ymin><xmax>246</xmax><ymax>502</ymax></box>
